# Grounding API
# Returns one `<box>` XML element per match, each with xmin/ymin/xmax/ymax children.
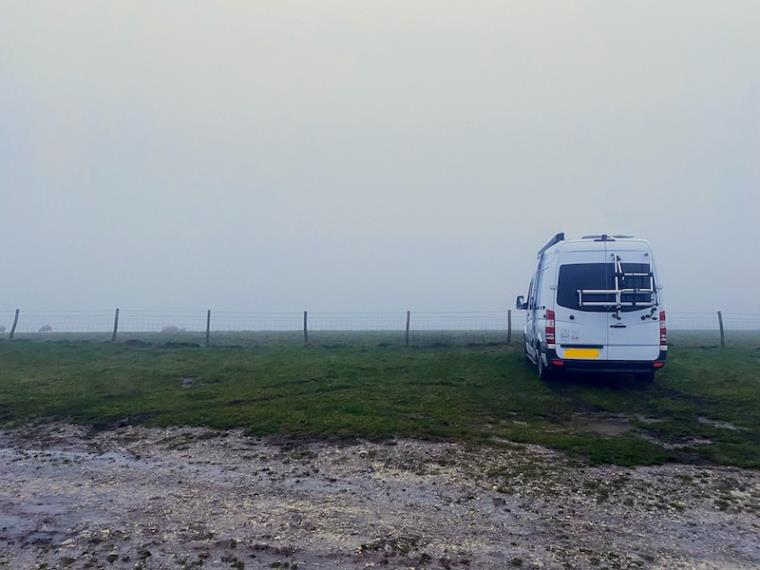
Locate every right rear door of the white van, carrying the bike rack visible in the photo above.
<box><xmin>607</xmin><ymin>247</ymin><xmax>660</xmax><ymax>360</ymax></box>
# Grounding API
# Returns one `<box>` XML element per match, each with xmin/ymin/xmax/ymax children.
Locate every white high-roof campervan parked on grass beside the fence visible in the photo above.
<box><xmin>517</xmin><ymin>234</ymin><xmax>668</xmax><ymax>382</ymax></box>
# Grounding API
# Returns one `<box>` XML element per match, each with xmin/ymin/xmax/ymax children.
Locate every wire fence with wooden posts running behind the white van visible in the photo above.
<box><xmin>0</xmin><ymin>309</ymin><xmax>760</xmax><ymax>346</ymax></box>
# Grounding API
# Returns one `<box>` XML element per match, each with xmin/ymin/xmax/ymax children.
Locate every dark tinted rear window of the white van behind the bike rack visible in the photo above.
<box><xmin>557</xmin><ymin>263</ymin><xmax>652</xmax><ymax>312</ymax></box>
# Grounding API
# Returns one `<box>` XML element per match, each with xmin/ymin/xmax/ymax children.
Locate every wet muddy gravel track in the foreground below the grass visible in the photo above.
<box><xmin>0</xmin><ymin>424</ymin><xmax>760</xmax><ymax>569</ymax></box>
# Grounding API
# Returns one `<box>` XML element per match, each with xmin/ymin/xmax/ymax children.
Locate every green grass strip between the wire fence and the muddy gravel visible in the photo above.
<box><xmin>0</xmin><ymin>333</ymin><xmax>760</xmax><ymax>468</ymax></box>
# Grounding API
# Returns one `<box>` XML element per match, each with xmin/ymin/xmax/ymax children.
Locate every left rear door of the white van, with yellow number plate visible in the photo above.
<box><xmin>554</xmin><ymin>249</ymin><xmax>609</xmax><ymax>360</ymax></box>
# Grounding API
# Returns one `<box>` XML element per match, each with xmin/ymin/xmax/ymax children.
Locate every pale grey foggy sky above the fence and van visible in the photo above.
<box><xmin>0</xmin><ymin>0</ymin><xmax>760</xmax><ymax>313</ymax></box>
